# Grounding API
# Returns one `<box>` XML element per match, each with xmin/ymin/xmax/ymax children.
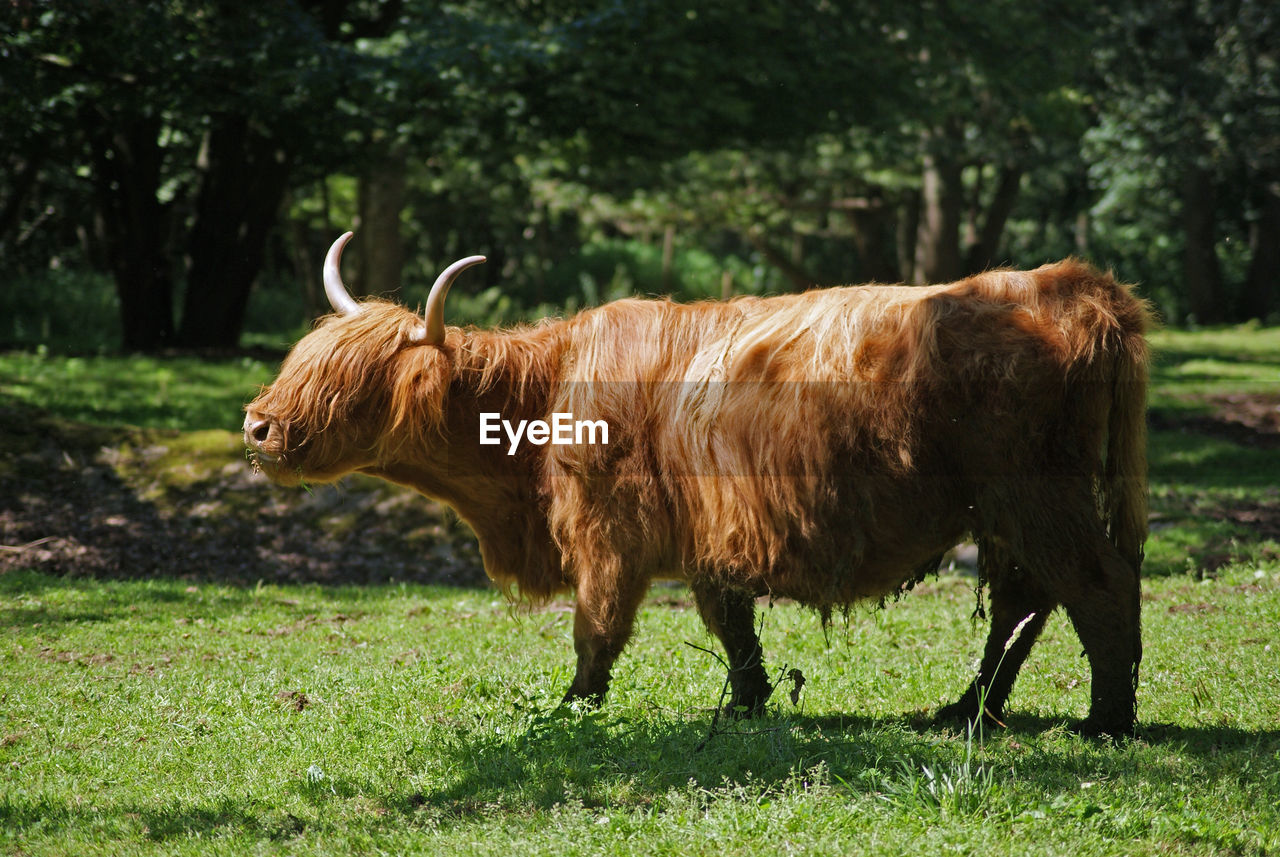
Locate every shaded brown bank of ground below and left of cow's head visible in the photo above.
<box><xmin>0</xmin><ymin>404</ymin><xmax>485</xmax><ymax>585</ymax></box>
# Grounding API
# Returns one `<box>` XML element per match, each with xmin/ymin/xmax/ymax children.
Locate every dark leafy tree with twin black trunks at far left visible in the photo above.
<box><xmin>8</xmin><ymin>0</ymin><xmax>409</xmax><ymax>350</ymax></box>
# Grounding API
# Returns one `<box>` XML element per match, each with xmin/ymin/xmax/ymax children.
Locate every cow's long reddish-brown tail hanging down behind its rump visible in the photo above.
<box><xmin>1102</xmin><ymin>287</ymin><xmax>1149</xmax><ymax>574</ymax></box>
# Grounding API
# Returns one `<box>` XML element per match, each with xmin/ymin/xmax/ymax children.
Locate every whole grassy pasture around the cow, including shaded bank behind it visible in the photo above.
<box><xmin>0</xmin><ymin>327</ymin><xmax>1280</xmax><ymax>854</ymax></box>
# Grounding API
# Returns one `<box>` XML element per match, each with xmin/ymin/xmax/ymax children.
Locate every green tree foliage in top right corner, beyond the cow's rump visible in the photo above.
<box><xmin>1089</xmin><ymin>0</ymin><xmax>1280</xmax><ymax>321</ymax></box>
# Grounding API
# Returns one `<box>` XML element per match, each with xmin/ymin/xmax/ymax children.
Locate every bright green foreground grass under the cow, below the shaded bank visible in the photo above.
<box><xmin>0</xmin><ymin>564</ymin><xmax>1280</xmax><ymax>854</ymax></box>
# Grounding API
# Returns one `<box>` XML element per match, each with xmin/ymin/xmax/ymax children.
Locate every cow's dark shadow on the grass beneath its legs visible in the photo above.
<box><xmin>407</xmin><ymin>710</ymin><xmax>1280</xmax><ymax>816</ymax></box>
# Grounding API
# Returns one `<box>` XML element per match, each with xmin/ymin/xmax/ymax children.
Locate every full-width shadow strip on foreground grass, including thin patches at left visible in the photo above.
<box><xmin>0</xmin><ymin>709</ymin><xmax>1280</xmax><ymax>840</ymax></box>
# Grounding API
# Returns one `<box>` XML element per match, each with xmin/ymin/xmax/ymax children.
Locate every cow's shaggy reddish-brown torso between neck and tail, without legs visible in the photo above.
<box><xmin>542</xmin><ymin>262</ymin><xmax>1144</xmax><ymax>605</ymax></box>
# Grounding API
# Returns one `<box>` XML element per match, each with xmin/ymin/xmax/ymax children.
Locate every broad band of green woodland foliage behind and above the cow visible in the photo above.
<box><xmin>0</xmin><ymin>0</ymin><xmax>1280</xmax><ymax>347</ymax></box>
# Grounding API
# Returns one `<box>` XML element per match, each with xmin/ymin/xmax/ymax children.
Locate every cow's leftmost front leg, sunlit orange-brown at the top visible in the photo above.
<box><xmin>564</xmin><ymin>576</ymin><xmax>646</xmax><ymax>707</ymax></box>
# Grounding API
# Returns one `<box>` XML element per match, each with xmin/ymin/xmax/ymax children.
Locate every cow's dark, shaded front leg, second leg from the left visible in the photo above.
<box><xmin>691</xmin><ymin>582</ymin><xmax>773</xmax><ymax>716</ymax></box>
